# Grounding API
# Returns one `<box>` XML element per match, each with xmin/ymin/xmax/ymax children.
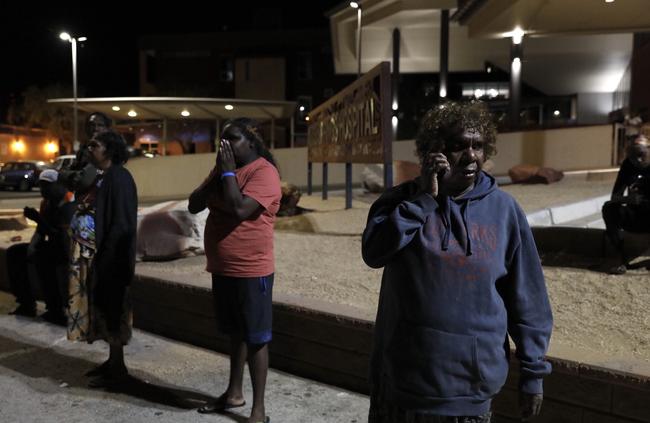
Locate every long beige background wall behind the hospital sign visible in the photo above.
<box><xmin>127</xmin><ymin>125</ymin><xmax>613</xmax><ymax>198</ymax></box>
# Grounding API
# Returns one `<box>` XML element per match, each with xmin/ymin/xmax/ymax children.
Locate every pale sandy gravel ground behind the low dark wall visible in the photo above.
<box><xmin>5</xmin><ymin>179</ymin><xmax>650</xmax><ymax>368</ymax></box>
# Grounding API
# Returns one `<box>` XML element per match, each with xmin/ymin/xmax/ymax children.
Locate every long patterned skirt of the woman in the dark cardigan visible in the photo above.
<box><xmin>68</xmin><ymin>238</ymin><xmax>133</xmax><ymax>345</ymax></box>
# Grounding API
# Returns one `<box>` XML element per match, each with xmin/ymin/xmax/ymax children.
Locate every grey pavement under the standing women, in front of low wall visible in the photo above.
<box><xmin>0</xmin><ymin>292</ymin><xmax>368</xmax><ymax>423</ymax></box>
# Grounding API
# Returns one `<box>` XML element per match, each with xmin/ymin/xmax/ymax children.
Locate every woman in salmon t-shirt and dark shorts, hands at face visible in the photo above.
<box><xmin>188</xmin><ymin>118</ymin><xmax>282</xmax><ymax>423</ymax></box>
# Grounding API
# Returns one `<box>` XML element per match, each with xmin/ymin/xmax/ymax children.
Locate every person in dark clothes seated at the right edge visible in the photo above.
<box><xmin>603</xmin><ymin>135</ymin><xmax>650</xmax><ymax>275</ymax></box>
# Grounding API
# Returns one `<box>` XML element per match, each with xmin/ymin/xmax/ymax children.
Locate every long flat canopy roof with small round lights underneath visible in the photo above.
<box><xmin>47</xmin><ymin>97</ymin><xmax>296</xmax><ymax>121</ymax></box>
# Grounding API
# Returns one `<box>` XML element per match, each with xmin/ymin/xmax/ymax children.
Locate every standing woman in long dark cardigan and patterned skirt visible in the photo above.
<box><xmin>68</xmin><ymin>131</ymin><xmax>138</xmax><ymax>387</ymax></box>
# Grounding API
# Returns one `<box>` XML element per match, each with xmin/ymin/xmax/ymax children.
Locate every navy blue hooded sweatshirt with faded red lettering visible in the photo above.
<box><xmin>362</xmin><ymin>172</ymin><xmax>553</xmax><ymax>416</ymax></box>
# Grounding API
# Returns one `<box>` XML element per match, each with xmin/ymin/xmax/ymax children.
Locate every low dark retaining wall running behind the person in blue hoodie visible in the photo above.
<box><xmin>132</xmin><ymin>275</ymin><xmax>650</xmax><ymax>423</ymax></box>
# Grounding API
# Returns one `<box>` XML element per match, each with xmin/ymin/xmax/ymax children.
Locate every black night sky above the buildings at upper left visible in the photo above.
<box><xmin>0</xmin><ymin>0</ymin><xmax>342</xmax><ymax>123</ymax></box>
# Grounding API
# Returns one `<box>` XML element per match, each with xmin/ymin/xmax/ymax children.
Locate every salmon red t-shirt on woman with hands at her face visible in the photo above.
<box><xmin>204</xmin><ymin>157</ymin><xmax>282</xmax><ymax>278</ymax></box>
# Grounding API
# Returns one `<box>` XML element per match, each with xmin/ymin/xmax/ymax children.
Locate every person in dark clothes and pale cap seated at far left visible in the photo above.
<box><xmin>7</xmin><ymin>169</ymin><xmax>74</xmax><ymax>325</ymax></box>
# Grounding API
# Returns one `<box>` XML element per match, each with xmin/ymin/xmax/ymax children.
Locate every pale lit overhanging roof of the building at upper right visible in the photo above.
<box><xmin>329</xmin><ymin>0</ymin><xmax>636</xmax><ymax>95</ymax></box>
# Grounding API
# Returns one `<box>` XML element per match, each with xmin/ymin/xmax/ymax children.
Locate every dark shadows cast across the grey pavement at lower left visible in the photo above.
<box><xmin>0</xmin><ymin>334</ymin><xmax>220</xmax><ymax>414</ymax></box>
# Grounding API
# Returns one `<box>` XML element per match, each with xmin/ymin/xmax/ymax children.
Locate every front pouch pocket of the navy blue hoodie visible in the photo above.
<box><xmin>388</xmin><ymin>326</ymin><xmax>482</xmax><ymax>398</ymax></box>
